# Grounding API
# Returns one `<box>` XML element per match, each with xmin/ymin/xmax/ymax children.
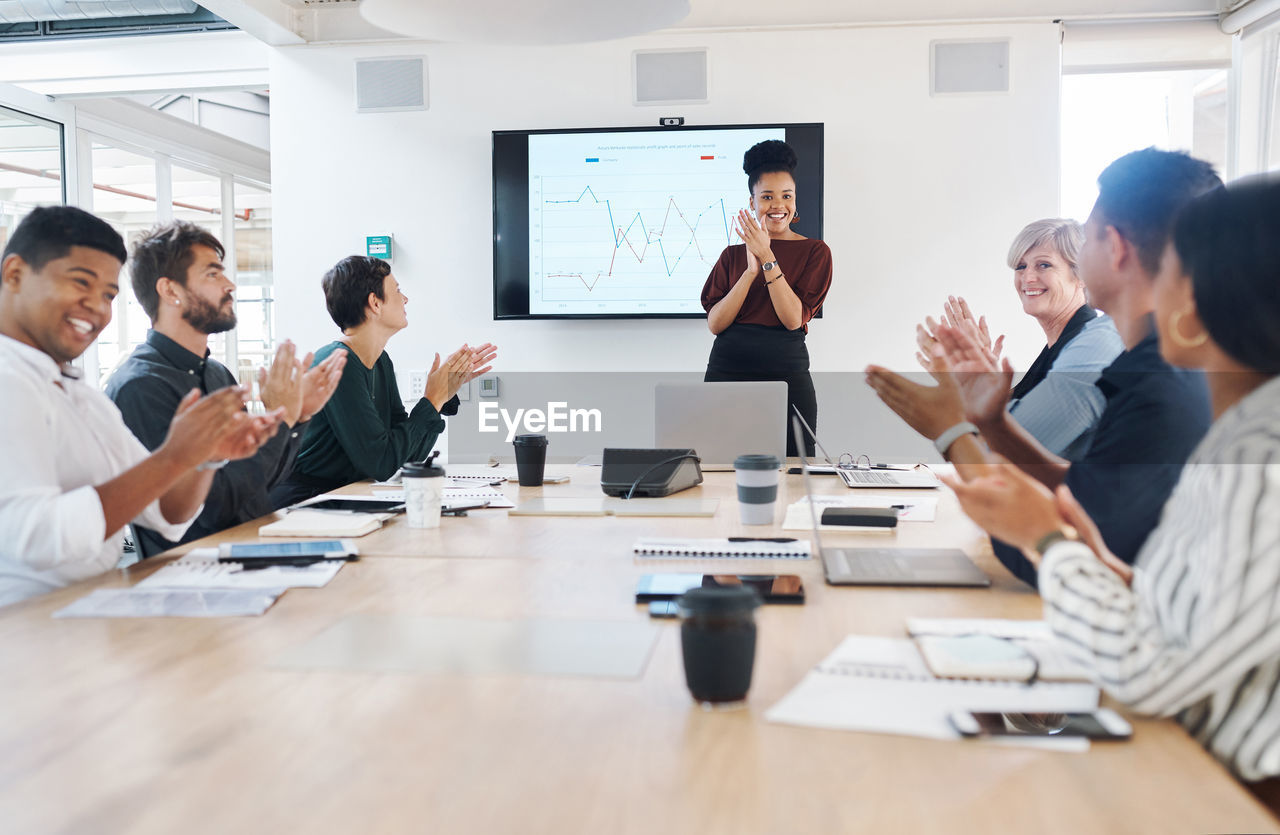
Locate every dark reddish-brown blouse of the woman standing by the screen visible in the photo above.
<box><xmin>703</xmin><ymin>238</ymin><xmax>831</xmax><ymax>333</ymax></box>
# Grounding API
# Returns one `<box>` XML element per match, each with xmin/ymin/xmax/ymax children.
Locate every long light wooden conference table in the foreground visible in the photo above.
<box><xmin>0</xmin><ymin>467</ymin><xmax>1277</xmax><ymax>835</ymax></box>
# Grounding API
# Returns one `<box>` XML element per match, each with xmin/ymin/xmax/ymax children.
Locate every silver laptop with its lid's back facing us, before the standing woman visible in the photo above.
<box><xmin>653</xmin><ymin>383</ymin><xmax>787</xmax><ymax>471</ymax></box>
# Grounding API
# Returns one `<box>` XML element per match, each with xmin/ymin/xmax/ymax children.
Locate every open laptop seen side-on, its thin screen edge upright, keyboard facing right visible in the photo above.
<box><xmin>792</xmin><ymin>418</ymin><xmax>991</xmax><ymax>587</ymax></box>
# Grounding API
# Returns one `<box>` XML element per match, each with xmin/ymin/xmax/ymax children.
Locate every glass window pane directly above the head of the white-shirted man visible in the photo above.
<box><xmin>0</xmin><ymin>108</ymin><xmax>65</xmax><ymax>256</ymax></box>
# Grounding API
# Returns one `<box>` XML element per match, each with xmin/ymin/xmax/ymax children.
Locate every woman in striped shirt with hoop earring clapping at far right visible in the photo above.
<box><xmin>948</xmin><ymin>177</ymin><xmax>1280</xmax><ymax>788</ymax></box>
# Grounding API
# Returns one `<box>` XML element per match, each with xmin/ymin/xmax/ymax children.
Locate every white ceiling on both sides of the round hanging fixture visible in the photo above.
<box><xmin>201</xmin><ymin>0</ymin><xmax>1244</xmax><ymax>45</ymax></box>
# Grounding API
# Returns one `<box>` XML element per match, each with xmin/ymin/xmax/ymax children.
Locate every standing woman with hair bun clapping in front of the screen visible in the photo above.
<box><xmin>703</xmin><ymin>140</ymin><xmax>831</xmax><ymax>456</ymax></box>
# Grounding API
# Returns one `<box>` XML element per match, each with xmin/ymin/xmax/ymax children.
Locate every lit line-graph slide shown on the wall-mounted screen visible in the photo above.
<box><xmin>526</xmin><ymin>127</ymin><xmax>785</xmax><ymax>316</ymax></box>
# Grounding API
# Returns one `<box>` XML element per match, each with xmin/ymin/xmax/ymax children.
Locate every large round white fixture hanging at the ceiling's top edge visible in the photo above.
<box><xmin>360</xmin><ymin>0</ymin><xmax>689</xmax><ymax>44</ymax></box>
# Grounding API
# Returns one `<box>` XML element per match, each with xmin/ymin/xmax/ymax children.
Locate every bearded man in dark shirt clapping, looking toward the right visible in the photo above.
<box><xmin>106</xmin><ymin>220</ymin><xmax>346</xmax><ymax>557</ymax></box>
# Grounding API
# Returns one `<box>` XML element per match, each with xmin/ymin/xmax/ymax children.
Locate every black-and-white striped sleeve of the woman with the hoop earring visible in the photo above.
<box><xmin>1039</xmin><ymin>446</ymin><xmax>1280</xmax><ymax>716</ymax></box>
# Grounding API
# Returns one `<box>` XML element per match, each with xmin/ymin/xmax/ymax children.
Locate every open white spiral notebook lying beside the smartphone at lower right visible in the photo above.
<box><xmin>764</xmin><ymin>635</ymin><xmax>1098</xmax><ymax>749</ymax></box>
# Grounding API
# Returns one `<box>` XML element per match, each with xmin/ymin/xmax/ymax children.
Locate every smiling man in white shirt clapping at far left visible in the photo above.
<box><xmin>0</xmin><ymin>206</ymin><xmax>280</xmax><ymax>606</ymax></box>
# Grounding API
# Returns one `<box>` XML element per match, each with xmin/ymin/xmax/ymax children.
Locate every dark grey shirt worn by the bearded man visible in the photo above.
<box><xmin>106</xmin><ymin>330</ymin><xmax>302</xmax><ymax>557</ymax></box>
